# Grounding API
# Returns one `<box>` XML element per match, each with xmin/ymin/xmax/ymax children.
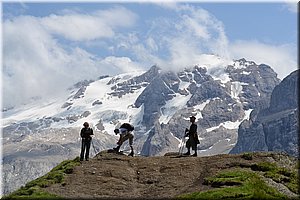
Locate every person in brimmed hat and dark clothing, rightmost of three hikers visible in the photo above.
<box><xmin>184</xmin><ymin>116</ymin><xmax>199</xmax><ymax>157</ymax></box>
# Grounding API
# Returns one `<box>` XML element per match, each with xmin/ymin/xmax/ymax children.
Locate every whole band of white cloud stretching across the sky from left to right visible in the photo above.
<box><xmin>3</xmin><ymin>2</ymin><xmax>297</xmax><ymax>106</ymax></box>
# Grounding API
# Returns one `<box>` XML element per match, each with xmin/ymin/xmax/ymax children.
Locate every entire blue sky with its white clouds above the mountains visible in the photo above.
<box><xmin>2</xmin><ymin>2</ymin><xmax>298</xmax><ymax>106</ymax></box>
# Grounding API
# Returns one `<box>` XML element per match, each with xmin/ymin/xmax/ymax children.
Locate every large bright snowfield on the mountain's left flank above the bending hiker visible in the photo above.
<box><xmin>56</xmin><ymin>72</ymin><xmax>145</xmax><ymax>135</ymax></box>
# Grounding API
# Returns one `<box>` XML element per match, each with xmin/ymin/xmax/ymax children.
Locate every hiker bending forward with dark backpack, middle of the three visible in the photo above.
<box><xmin>113</xmin><ymin>123</ymin><xmax>134</xmax><ymax>156</ymax></box>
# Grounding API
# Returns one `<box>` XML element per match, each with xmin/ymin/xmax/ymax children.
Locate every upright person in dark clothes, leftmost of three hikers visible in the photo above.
<box><xmin>80</xmin><ymin>122</ymin><xmax>94</xmax><ymax>161</ymax></box>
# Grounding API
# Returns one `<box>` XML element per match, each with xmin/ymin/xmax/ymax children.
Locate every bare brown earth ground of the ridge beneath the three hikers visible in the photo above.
<box><xmin>45</xmin><ymin>151</ymin><xmax>296</xmax><ymax>199</ymax></box>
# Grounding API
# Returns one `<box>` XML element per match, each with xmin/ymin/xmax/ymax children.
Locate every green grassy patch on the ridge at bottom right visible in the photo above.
<box><xmin>179</xmin><ymin>153</ymin><xmax>299</xmax><ymax>199</ymax></box>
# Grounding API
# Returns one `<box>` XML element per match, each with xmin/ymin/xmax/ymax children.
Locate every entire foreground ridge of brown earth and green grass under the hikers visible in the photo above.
<box><xmin>4</xmin><ymin>151</ymin><xmax>299</xmax><ymax>199</ymax></box>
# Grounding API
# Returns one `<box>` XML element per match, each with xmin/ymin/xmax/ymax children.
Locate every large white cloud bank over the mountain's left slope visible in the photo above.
<box><xmin>2</xmin><ymin>8</ymin><xmax>138</xmax><ymax>107</ymax></box>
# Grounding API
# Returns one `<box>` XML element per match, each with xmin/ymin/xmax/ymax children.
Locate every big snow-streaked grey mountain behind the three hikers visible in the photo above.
<box><xmin>2</xmin><ymin>55</ymin><xmax>279</xmax><ymax>193</ymax></box>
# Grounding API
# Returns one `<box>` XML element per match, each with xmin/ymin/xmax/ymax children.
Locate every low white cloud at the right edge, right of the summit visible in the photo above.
<box><xmin>230</xmin><ymin>41</ymin><xmax>297</xmax><ymax>79</ymax></box>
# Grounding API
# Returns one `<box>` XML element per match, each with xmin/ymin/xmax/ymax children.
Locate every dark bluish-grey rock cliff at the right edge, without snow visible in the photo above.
<box><xmin>230</xmin><ymin>70</ymin><xmax>299</xmax><ymax>156</ymax></box>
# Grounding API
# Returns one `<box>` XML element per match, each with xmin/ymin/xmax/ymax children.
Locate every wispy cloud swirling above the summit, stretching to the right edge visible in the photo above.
<box><xmin>127</xmin><ymin>4</ymin><xmax>297</xmax><ymax>79</ymax></box>
